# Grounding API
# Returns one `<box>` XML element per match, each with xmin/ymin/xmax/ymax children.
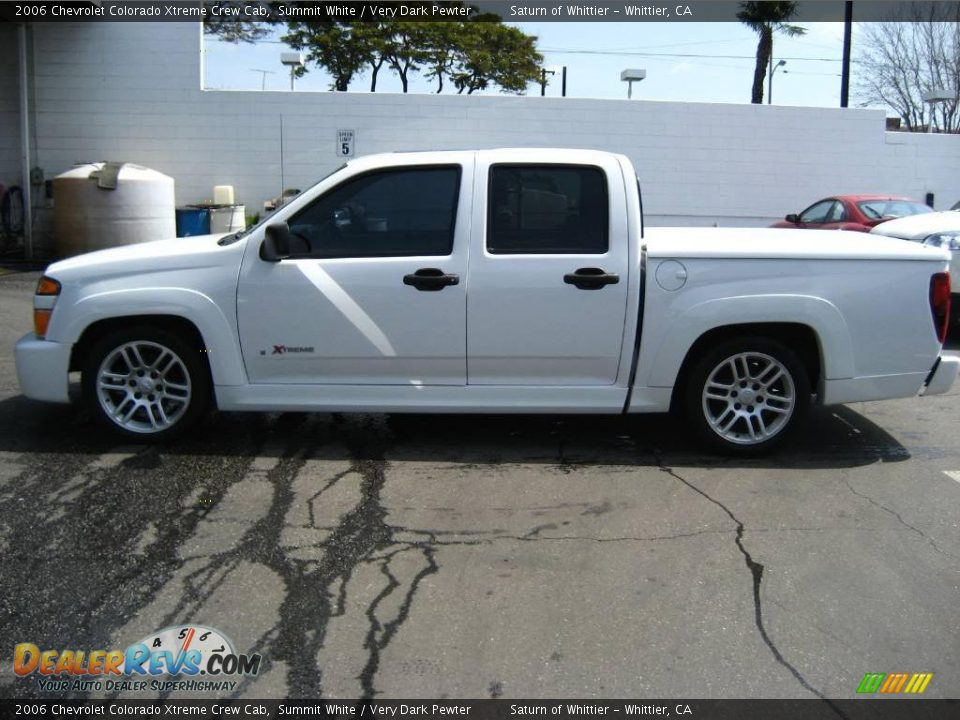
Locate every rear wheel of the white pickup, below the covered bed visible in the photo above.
<box><xmin>683</xmin><ymin>337</ymin><xmax>811</xmax><ymax>457</ymax></box>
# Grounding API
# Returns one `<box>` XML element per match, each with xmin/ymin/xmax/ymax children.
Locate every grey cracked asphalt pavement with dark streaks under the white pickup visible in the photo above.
<box><xmin>0</xmin><ymin>273</ymin><xmax>960</xmax><ymax>698</ymax></box>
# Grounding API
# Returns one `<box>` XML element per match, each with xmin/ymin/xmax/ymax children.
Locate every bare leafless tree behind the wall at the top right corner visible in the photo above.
<box><xmin>856</xmin><ymin>2</ymin><xmax>960</xmax><ymax>133</ymax></box>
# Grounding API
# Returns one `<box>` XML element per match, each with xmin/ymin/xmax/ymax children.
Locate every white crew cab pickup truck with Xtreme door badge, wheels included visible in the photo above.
<box><xmin>16</xmin><ymin>149</ymin><xmax>960</xmax><ymax>454</ymax></box>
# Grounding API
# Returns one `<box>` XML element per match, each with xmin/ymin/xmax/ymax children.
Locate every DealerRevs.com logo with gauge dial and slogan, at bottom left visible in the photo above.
<box><xmin>13</xmin><ymin>625</ymin><xmax>262</xmax><ymax>692</ymax></box>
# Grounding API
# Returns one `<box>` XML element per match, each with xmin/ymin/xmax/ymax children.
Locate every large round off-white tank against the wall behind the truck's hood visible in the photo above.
<box><xmin>53</xmin><ymin>163</ymin><xmax>177</xmax><ymax>257</ymax></box>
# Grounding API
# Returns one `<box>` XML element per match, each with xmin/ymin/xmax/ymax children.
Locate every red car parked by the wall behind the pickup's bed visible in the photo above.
<box><xmin>770</xmin><ymin>195</ymin><xmax>933</xmax><ymax>232</ymax></box>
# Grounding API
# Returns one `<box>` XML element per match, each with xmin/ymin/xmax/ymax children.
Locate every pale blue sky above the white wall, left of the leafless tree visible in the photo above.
<box><xmin>204</xmin><ymin>22</ymin><xmax>857</xmax><ymax>107</ymax></box>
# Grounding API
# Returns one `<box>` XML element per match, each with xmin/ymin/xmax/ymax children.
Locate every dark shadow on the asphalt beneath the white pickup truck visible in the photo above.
<box><xmin>0</xmin><ymin>396</ymin><xmax>911</xmax><ymax>469</ymax></box>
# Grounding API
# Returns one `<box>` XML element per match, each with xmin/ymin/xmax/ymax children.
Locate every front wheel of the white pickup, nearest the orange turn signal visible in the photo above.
<box><xmin>82</xmin><ymin>325</ymin><xmax>210</xmax><ymax>442</ymax></box>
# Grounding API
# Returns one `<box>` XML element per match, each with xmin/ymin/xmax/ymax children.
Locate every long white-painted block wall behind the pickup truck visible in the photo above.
<box><xmin>0</xmin><ymin>23</ymin><xmax>960</xmax><ymax>236</ymax></box>
